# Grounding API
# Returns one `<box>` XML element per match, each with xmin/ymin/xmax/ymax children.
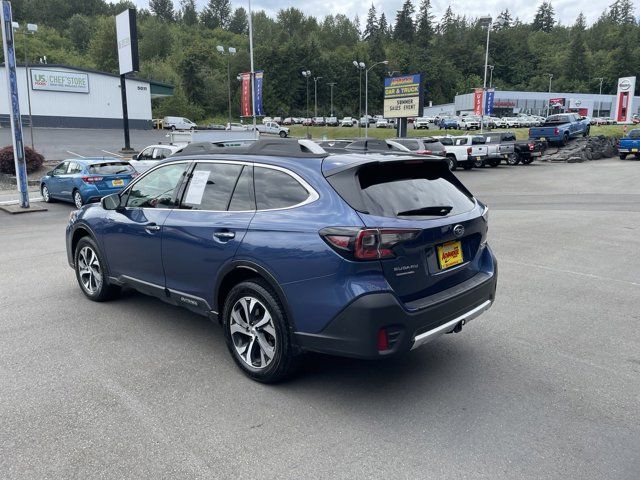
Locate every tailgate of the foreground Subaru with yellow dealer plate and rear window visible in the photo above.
<box><xmin>329</xmin><ymin>160</ymin><xmax>487</xmax><ymax>302</ymax></box>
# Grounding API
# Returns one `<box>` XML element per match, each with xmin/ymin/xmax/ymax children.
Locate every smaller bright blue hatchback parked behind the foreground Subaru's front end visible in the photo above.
<box><xmin>40</xmin><ymin>157</ymin><xmax>138</xmax><ymax>208</ymax></box>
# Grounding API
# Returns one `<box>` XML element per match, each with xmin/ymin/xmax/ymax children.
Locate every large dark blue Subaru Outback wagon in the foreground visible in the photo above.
<box><xmin>66</xmin><ymin>140</ymin><xmax>497</xmax><ymax>382</ymax></box>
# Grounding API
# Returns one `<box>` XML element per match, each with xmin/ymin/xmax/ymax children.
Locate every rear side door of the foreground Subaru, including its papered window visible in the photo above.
<box><xmin>162</xmin><ymin>161</ymin><xmax>255</xmax><ymax>311</ymax></box>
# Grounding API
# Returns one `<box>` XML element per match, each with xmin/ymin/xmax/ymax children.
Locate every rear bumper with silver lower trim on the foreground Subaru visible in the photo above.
<box><xmin>295</xmin><ymin>253</ymin><xmax>498</xmax><ymax>358</ymax></box>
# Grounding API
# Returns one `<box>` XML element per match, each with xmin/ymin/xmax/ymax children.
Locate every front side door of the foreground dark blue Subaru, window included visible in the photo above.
<box><xmin>102</xmin><ymin>162</ymin><xmax>189</xmax><ymax>294</ymax></box>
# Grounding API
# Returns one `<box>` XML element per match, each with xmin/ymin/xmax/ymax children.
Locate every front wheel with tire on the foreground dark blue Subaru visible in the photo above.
<box><xmin>73</xmin><ymin>237</ymin><xmax>120</xmax><ymax>302</ymax></box>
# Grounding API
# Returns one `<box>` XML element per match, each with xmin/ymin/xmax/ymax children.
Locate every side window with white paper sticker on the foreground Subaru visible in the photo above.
<box><xmin>185</xmin><ymin>163</ymin><xmax>242</xmax><ymax>211</ymax></box>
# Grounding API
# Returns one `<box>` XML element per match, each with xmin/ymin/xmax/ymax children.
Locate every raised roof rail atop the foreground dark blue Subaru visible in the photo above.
<box><xmin>174</xmin><ymin>138</ymin><xmax>327</xmax><ymax>158</ymax></box>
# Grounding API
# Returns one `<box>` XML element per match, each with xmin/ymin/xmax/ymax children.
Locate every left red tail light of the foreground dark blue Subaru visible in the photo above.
<box><xmin>320</xmin><ymin>227</ymin><xmax>420</xmax><ymax>260</ymax></box>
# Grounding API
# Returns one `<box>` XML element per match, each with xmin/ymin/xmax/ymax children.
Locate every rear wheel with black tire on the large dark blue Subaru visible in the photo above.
<box><xmin>222</xmin><ymin>279</ymin><xmax>296</xmax><ymax>383</ymax></box>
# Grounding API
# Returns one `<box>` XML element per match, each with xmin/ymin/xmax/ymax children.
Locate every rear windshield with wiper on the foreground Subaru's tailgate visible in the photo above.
<box><xmin>348</xmin><ymin>162</ymin><xmax>475</xmax><ymax>218</ymax></box>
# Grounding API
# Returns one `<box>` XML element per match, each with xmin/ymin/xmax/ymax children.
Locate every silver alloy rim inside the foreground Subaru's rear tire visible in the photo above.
<box><xmin>229</xmin><ymin>296</ymin><xmax>277</xmax><ymax>370</ymax></box>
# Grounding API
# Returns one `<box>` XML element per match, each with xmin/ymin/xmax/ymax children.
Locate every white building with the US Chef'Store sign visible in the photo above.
<box><xmin>0</xmin><ymin>64</ymin><xmax>173</xmax><ymax>129</ymax></box>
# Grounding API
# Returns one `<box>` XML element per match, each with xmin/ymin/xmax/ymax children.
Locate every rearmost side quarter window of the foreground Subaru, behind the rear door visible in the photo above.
<box><xmin>254</xmin><ymin>167</ymin><xmax>309</xmax><ymax>210</ymax></box>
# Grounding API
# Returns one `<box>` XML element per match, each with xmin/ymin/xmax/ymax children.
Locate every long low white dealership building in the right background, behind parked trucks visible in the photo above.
<box><xmin>424</xmin><ymin>90</ymin><xmax>640</xmax><ymax>117</ymax></box>
